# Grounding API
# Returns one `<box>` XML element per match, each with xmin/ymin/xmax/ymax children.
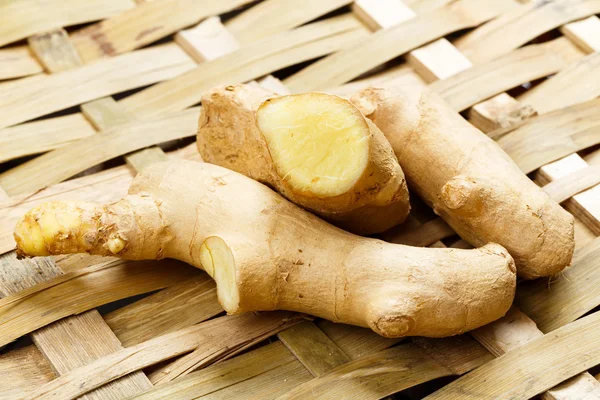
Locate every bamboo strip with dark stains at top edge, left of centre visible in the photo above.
<box><xmin>73</xmin><ymin>0</ymin><xmax>252</xmax><ymax>63</ymax></box>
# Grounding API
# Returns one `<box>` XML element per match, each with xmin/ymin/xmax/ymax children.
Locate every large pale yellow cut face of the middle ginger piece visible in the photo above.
<box><xmin>256</xmin><ymin>93</ymin><xmax>370</xmax><ymax>197</ymax></box>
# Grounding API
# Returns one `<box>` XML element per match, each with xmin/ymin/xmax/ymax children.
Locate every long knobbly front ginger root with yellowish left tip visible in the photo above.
<box><xmin>15</xmin><ymin>161</ymin><xmax>516</xmax><ymax>337</ymax></box>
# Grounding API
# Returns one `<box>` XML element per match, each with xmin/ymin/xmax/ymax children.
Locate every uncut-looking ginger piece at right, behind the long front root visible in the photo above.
<box><xmin>351</xmin><ymin>85</ymin><xmax>575</xmax><ymax>279</ymax></box>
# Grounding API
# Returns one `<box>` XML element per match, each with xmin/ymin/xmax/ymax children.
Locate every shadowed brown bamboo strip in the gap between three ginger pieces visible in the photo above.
<box><xmin>381</xmin><ymin>218</ymin><xmax>456</xmax><ymax>247</ymax></box>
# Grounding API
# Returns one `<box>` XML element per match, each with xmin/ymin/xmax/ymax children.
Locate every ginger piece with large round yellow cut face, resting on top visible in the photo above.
<box><xmin>197</xmin><ymin>85</ymin><xmax>410</xmax><ymax>234</ymax></box>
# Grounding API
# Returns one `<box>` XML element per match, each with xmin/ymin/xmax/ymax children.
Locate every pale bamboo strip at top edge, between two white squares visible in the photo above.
<box><xmin>225</xmin><ymin>0</ymin><xmax>352</xmax><ymax>45</ymax></box>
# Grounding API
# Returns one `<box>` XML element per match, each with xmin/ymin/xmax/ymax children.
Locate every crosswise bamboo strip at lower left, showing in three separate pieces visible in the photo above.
<box><xmin>0</xmin><ymin>253</ymin><xmax>151</xmax><ymax>399</ymax></box>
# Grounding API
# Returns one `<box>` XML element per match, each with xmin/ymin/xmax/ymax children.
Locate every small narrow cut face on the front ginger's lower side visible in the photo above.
<box><xmin>200</xmin><ymin>236</ymin><xmax>240</xmax><ymax>314</ymax></box>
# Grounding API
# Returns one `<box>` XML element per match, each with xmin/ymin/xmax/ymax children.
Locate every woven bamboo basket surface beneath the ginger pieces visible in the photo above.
<box><xmin>0</xmin><ymin>0</ymin><xmax>600</xmax><ymax>399</ymax></box>
